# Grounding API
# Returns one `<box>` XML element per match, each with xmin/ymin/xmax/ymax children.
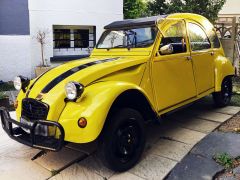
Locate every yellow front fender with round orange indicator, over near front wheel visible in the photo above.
<box><xmin>58</xmin><ymin>81</ymin><xmax>151</xmax><ymax>143</ymax></box>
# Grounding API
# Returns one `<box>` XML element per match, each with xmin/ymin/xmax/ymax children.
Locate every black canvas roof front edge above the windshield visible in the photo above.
<box><xmin>104</xmin><ymin>15</ymin><xmax>167</xmax><ymax>29</ymax></box>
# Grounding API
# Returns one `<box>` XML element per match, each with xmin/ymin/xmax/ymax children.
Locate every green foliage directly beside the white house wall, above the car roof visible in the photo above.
<box><xmin>123</xmin><ymin>0</ymin><xmax>146</xmax><ymax>19</ymax></box>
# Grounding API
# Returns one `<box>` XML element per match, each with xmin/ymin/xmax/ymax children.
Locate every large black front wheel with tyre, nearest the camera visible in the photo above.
<box><xmin>100</xmin><ymin>108</ymin><xmax>145</xmax><ymax>172</ymax></box>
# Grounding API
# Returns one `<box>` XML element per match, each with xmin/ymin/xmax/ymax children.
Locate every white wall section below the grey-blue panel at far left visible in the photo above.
<box><xmin>0</xmin><ymin>35</ymin><xmax>31</xmax><ymax>81</ymax></box>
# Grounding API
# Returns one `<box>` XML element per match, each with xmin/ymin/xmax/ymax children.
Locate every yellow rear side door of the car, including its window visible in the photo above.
<box><xmin>187</xmin><ymin>21</ymin><xmax>214</xmax><ymax>94</ymax></box>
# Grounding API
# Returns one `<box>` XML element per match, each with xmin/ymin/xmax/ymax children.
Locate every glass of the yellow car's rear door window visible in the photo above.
<box><xmin>188</xmin><ymin>23</ymin><xmax>211</xmax><ymax>51</ymax></box>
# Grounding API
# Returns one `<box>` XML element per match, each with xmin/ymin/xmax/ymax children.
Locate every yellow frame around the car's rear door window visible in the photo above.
<box><xmin>187</xmin><ymin>21</ymin><xmax>213</xmax><ymax>52</ymax></box>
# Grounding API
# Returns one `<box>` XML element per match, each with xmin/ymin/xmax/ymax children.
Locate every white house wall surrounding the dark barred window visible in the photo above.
<box><xmin>29</xmin><ymin>0</ymin><xmax>123</xmax><ymax>76</ymax></box>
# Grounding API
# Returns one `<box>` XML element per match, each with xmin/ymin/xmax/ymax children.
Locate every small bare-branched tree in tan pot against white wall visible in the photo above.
<box><xmin>35</xmin><ymin>30</ymin><xmax>50</xmax><ymax>76</ymax></box>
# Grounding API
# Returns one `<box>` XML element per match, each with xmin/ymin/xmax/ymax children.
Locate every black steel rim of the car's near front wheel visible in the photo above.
<box><xmin>113</xmin><ymin>119</ymin><xmax>142</xmax><ymax>163</ymax></box>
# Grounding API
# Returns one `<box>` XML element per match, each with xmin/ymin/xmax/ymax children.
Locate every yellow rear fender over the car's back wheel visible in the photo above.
<box><xmin>215</xmin><ymin>56</ymin><xmax>235</xmax><ymax>92</ymax></box>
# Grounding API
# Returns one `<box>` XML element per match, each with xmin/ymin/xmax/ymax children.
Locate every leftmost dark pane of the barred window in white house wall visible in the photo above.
<box><xmin>54</xmin><ymin>29</ymin><xmax>71</xmax><ymax>48</ymax></box>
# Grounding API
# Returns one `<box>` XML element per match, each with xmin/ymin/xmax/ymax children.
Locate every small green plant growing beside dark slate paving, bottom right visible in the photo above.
<box><xmin>214</xmin><ymin>153</ymin><xmax>234</xmax><ymax>169</ymax></box>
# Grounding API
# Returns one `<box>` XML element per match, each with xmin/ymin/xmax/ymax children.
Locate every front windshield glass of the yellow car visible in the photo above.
<box><xmin>97</xmin><ymin>27</ymin><xmax>157</xmax><ymax>49</ymax></box>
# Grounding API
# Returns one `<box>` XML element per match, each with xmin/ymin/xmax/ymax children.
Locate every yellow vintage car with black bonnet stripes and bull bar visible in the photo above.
<box><xmin>1</xmin><ymin>13</ymin><xmax>235</xmax><ymax>171</ymax></box>
